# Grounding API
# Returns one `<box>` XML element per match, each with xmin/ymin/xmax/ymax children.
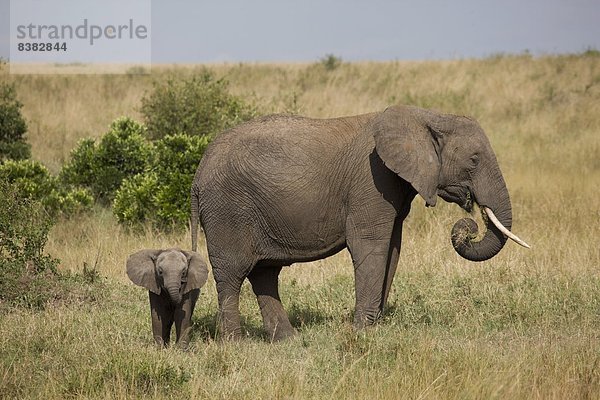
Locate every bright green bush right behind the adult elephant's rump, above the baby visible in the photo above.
<box><xmin>113</xmin><ymin>135</ymin><xmax>209</xmax><ymax>228</ymax></box>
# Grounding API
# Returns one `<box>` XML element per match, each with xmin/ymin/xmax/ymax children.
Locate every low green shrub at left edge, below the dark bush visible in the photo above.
<box><xmin>0</xmin><ymin>160</ymin><xmax>94</xmax><ymax>216</ymax></box>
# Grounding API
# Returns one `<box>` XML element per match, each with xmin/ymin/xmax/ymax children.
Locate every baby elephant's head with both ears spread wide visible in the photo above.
<box><xmin>127</xmin><ymin>249</ymin><xmax>208</xmax><ymax>304</ymax></box>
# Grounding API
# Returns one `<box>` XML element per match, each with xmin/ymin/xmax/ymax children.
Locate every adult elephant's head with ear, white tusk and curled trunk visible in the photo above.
<box><xmin>373</xmin><ymin>106</ymin><xmax>529</xmax><ymax>261</ymax></box>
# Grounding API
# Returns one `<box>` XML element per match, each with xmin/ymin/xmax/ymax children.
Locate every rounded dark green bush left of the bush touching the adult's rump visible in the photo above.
<box><xmin>60</xmin><ymin>117</ymin><xmax>152</xmax><ymax>203</ymax></box>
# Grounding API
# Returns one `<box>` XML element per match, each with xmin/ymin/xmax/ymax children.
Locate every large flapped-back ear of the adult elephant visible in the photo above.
<box><xmin>373</xmin><ymin>106</ymin><xmax>443</xmax><ymax>206</ymax></box>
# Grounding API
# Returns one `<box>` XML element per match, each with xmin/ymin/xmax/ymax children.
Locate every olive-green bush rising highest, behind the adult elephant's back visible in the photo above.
<box><xmin>141</xmin><ymin>71</ymin><xmax>257</xmax><ymax>140</ymax></box>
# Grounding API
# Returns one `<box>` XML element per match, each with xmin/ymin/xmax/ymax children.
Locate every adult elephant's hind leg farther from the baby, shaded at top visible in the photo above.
<box><xmin>248</xmin><ymin>265</ymin><xmax>296</xmax><ymax>341</ymax></box>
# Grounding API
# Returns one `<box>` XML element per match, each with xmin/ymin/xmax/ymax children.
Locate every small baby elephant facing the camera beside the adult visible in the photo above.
<box><xmin>127</xmin><ymin>249</ymin><xmax>208</xmax><ymax>349</ymax></box>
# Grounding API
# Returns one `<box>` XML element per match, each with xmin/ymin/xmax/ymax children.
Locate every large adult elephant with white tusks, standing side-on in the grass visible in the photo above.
<box><xmin>191</xmin><ymin>106</ymin><xmax>519</xmax><ymax>340</ymax></box>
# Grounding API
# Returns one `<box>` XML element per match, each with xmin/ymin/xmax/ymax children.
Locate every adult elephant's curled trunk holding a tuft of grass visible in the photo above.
<box><xmin>452</xmin><ymin>167</ymin><xmax>512</xmax><ymax>261</ymax></box>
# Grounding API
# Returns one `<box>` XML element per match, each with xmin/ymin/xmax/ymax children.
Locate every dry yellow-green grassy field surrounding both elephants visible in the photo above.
<box><xmin>0</xmin><ymin>51</ymin><xmax>600</xmax><ymax>399</ymax></box>
